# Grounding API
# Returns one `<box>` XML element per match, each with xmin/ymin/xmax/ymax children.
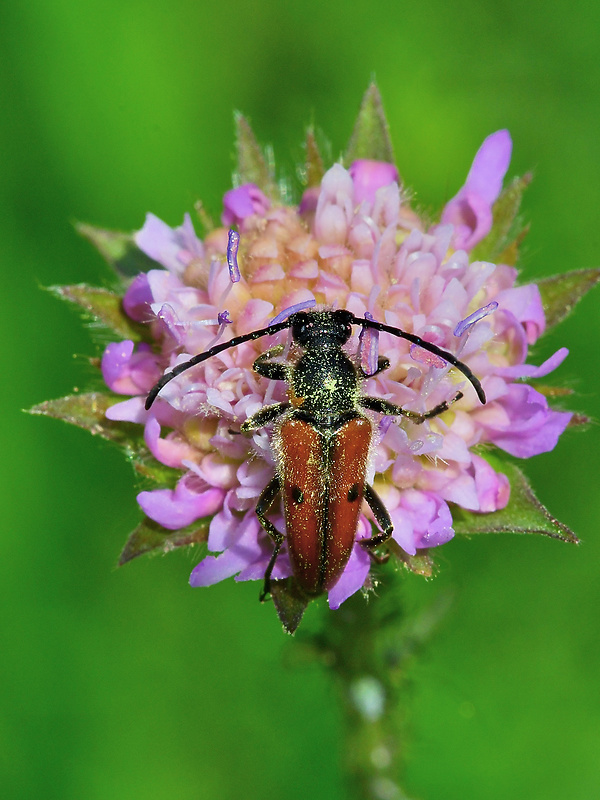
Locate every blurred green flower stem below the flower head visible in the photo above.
<box><xmin>316</xmin><ymin>575</ymin><xmax>448</xmax><ymax>800</ymax></box>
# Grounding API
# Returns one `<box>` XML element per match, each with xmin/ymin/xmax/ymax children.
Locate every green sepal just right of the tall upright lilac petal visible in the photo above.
<box><xmin>472</xmin><ymin>173</ymin><xmax>531</xmax><ymax>267</ymax></box>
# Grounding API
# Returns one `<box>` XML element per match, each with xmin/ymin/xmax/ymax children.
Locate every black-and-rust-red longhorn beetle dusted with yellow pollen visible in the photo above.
<box><xmin>146</xmin><ymin>309</ymin><xmax>485</xmax><ymax>601</ymax></box>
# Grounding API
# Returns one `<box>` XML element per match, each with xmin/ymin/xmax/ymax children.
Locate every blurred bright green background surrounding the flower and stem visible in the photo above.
<box><xmin>0</xmin><ymin>0</ymin><xmax>600</xmax><ymax>800</ymax></box>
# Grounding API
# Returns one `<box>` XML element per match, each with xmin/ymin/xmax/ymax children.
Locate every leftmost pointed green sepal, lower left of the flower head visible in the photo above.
<box><xmin>29</xmin><ymin>392</ymin><xmax>182</xmax><ymax>487</ymax></box>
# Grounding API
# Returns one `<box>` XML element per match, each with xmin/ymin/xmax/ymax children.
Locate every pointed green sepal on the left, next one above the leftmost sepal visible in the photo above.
<box><xmin>48</xmin><ymin>283</ymin><xmax>152</xmax><ymax>342</ymax></box>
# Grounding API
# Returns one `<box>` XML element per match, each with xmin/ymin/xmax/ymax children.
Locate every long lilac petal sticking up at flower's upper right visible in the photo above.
<box><xmin>441</xmin><ymin>130</ymin><xmax>512</xmax><ymax>251</ymax></box>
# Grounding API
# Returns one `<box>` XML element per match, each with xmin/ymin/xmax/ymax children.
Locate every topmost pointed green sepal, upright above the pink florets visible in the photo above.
<box><xmin>344</xmin><ymin>83</ymin><xmax>394</xmax><ymax>165</ymax></box>
